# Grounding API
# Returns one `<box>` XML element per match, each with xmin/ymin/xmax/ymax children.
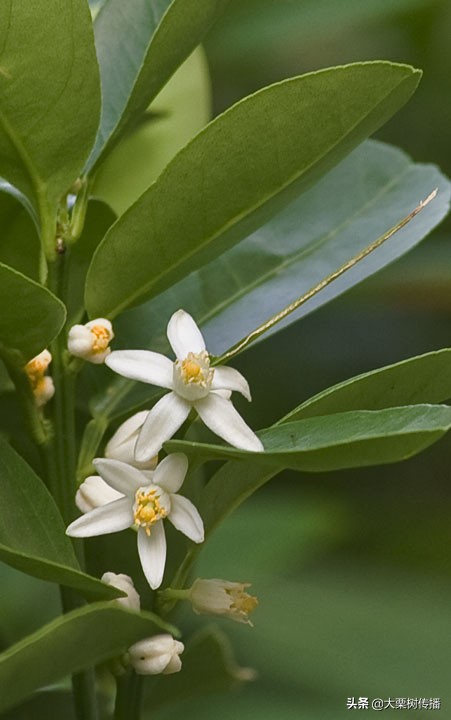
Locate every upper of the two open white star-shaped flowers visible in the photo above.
<box><xmin>105</xmin><ymin>310</ymin><xmax>264</xmax><ymax>462</ymax></box>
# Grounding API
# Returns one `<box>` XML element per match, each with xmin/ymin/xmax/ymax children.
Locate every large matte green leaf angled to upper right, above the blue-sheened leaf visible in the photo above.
<box><xmin>86</xmin><ymin>62</ymin><xmax>419</xmax><ymax>317</ymax></box>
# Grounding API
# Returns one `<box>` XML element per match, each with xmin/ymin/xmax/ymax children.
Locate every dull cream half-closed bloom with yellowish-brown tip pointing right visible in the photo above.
<box><xmin>189</xmin><ymin>578</ymin><xmax>258</xmax><ymax>626</ymax></box>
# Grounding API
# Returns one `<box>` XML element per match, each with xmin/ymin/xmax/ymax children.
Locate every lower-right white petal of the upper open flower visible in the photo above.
<box><xmin>194</xmin><ymin>393</ymin><xmax>264</xmax><ymax>452</ymax></box>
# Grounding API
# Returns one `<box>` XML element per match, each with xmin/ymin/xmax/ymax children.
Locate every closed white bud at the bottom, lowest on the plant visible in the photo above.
<box><xmin>128</xmin><ymin>635</ymin><xmax>185</xmax><ymax>675</ymax></box>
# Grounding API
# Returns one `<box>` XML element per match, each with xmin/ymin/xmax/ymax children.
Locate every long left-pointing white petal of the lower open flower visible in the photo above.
<box><xmin>66</xmin><ymin>498</ymin><xmax>134</xmax><ymax>537</ymax></box>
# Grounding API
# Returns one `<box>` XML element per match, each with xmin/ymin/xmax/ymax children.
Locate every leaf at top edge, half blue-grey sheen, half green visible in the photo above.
<box><xmin>88</xmin><ymin>0</ymin><xmax>228</xmax><ymax>168</ymax></box>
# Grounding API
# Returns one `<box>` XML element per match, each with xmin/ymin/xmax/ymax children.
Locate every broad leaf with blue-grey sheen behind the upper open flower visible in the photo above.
<box><xmin>89</xmin><ymin>140</ymin><xmax>450</xmax><ymax>422</ymax></box>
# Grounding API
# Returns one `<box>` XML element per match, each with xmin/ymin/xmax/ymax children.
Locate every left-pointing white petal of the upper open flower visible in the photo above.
<box><xmin>105</xmin><ymin>350</ymin><xmax>174</xmax><ymax>389</ymax></box>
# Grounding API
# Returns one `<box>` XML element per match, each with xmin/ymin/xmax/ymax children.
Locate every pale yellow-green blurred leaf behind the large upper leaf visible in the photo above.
<box><xmin>92</xmin><ymin>47</ymin><xmax>211</xmax><ymax>215</ymax></box>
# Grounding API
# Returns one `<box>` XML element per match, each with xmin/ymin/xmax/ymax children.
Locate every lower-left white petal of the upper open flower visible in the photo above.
<box><xmin>135</xmin><ymin>392</ymin><xmax>191</xmax><ymax>462</ymax></box>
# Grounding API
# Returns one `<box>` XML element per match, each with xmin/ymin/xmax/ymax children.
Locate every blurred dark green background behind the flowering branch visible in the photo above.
<box><xmin>0</xmin><ymin>0</ymin><xmax>451</xmax><ymax>720</ymax></box>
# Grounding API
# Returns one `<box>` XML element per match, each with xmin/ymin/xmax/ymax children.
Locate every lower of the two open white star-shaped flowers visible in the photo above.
<box><xmin>66</xmin><ymin>453</ymin><xmax>204</xmax><ymax>590</ymax></box>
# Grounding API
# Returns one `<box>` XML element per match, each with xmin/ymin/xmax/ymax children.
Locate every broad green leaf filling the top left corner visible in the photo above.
<box><xmin>0</xmin><ymin>0</ymin><xmax>100</xmax><ymax>214</ymax></box>
